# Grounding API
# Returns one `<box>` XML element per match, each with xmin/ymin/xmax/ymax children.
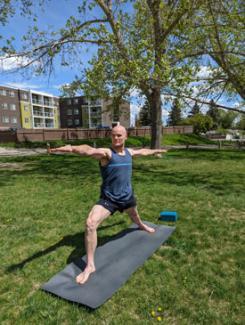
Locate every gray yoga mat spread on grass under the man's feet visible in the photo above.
<box><xmin>42</xmin><ymin>221</ymin><xmax>175</xmax><ymax>309</ymax></box>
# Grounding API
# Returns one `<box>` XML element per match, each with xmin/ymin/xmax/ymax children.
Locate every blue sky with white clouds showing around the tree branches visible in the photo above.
<box><xmin>0</xmin><ymin>0</ymin><xmax>242</xmax><ymax>124</ymax></box>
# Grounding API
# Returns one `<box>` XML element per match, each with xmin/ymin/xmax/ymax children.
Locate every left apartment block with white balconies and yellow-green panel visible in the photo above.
<box><xmin>0</xmin><ymin>86</ymin><xmax>60</xmax><ymax>129</ymax></box>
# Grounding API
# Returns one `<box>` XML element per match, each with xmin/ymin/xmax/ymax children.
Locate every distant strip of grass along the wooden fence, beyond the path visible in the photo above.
<box><xmin>1</xmin><ymin>134</ymin><xmax>215</xmax><ymax>148</ymax></box>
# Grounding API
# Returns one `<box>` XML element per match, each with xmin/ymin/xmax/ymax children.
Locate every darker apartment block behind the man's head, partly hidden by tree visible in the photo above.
<box><xmin>59</xmin><ymin>96</ymin><xmax>130</xmax><ymax>128</ymax></box>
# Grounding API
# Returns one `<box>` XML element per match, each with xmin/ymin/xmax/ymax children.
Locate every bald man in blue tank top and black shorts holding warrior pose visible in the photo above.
<box><xmin>48</xmin><ymin>125</ymin><xmax>166</xmax><ymax>284</ymax></box>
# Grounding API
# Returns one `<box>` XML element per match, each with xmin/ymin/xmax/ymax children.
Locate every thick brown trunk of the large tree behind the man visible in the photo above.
<box><xmin>148</xmin><ymin>87</ymin><xmax>162</xmax><ymax>149</ymax></box>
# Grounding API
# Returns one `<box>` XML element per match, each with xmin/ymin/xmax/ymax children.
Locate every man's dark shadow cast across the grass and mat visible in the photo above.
<box><xmin>6</xmin><ymin>221</ymin><xmax>128</xmax><ymax>273</ymax></box>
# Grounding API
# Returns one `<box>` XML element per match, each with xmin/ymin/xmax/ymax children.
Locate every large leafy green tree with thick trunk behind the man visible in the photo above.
<box><xmin>2</xmin><ymin>0</ymin><xmax>242</xmax><ymax>148</ymax></box>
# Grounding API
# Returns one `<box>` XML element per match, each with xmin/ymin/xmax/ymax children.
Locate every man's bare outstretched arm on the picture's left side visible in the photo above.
<box><xmin>47</xmin><ymin>144</ymin><xmax>110</xmax><ymax>159</ymax></box>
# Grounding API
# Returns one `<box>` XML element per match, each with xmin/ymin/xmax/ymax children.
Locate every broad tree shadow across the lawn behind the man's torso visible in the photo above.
<box><xmin>0</xmin><ymin>150</ymin><xmax>245</xmax><ymax>195</ymax></box>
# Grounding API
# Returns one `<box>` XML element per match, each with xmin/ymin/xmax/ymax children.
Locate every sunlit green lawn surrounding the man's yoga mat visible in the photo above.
<box><xmin>0</xmin><ymin>150</ymin><xmax>245</xmax><ymax>325</ymax></box>
